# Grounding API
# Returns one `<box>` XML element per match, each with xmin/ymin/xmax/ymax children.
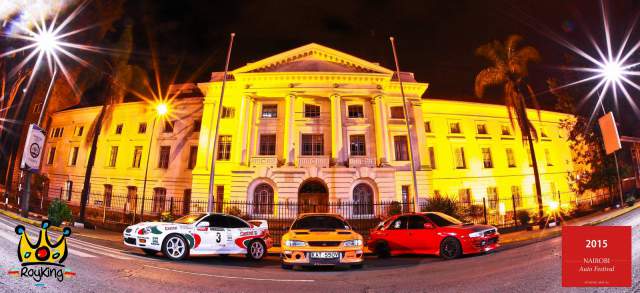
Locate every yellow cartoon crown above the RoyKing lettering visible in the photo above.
<box><xmin>16</xmin><ymin>221</ymin><xmax>71</xmax><ymax>267</ymax></box>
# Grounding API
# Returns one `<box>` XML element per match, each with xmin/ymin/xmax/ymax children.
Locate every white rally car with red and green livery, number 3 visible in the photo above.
<box><xmin>123</xmin><ymin>213</ymin><xmax>273</xmax><ymax>260</ymax></box>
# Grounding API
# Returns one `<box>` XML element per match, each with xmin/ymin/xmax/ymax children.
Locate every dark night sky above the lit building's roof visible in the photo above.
<box><xmin>117</xmin><ymin>0</ymin><xmax>640</xmax><ymax>131</ymax></box>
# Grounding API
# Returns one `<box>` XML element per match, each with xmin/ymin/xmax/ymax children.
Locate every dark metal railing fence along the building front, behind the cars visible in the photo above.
<box><xmin>2</xmin><ymin>190</ymin><xmax>612</xmax><ymax>244</ymax></box>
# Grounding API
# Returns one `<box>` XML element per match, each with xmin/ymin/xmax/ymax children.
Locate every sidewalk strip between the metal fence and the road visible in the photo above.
<box><xmin>0</xmin><ymin>204</ymin><xmax>640</xmax><ymax>254</ymax></box>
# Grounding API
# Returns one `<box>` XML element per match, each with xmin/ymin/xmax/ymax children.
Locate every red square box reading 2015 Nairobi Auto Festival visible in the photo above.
<box><xmin>562</xmin><ymin>226</ymin><xmax>631</xmax><ymax>287</ymax></box>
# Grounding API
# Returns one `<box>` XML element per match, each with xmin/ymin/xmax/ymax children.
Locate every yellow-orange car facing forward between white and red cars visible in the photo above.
<box><xmin>280</xmin><ymin>213</ymin><xmax>364</xmax><ymax>269</ymax></box>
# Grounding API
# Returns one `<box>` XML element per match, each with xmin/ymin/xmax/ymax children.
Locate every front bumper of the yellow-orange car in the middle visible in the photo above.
<box><xmin>280</xmin><ymin>247</ymin><xmax>364</xmax><ymax>266</ymax></box>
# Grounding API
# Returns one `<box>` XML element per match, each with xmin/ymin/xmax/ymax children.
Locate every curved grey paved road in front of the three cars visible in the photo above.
<box><xmin>0</xmin><ymin>209</ymin><xmax>640</xmax><ymax>293</ymax></box>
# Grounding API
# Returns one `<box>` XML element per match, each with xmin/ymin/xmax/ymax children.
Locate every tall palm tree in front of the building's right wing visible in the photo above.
<box><xmin>475</xmin><ymin>35</ymin><xmax>543</xmax><ymax>219</ymax></box>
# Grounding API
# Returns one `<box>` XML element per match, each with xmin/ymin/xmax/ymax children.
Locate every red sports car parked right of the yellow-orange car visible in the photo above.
<box><xmin>367</xmin><ymin>212</ymin><xmax>499</xmax><ymax>259</ymax></box>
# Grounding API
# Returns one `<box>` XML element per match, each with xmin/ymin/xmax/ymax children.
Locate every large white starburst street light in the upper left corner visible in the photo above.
<box><xmin>0</xmin><ymin>2</ymin><xmax>102</xmax><ymax>95</ymax></box>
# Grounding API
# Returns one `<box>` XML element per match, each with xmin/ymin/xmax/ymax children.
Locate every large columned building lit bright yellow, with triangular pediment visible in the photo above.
<box><xmin>38</xmin><ymin>44</ymin><xmax>573</xmax><ymax>213</ymax></box>
